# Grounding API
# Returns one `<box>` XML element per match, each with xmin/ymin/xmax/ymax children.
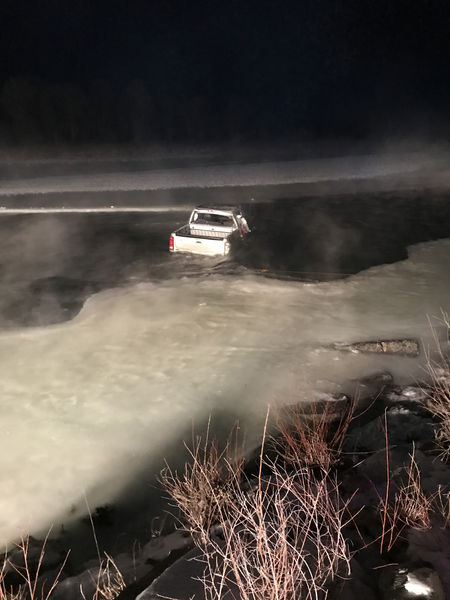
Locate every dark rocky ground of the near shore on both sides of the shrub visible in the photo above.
<box><xmin>0</xmin><ymin>342</ymin><xmax>450</xmax><ymax>600</ymax></box>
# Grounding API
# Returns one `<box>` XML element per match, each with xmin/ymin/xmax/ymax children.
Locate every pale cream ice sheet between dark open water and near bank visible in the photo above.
<box><xmin>0</xmin><ymin>240</ymin><xmax>450</xmax><ymax>543</ymax></box>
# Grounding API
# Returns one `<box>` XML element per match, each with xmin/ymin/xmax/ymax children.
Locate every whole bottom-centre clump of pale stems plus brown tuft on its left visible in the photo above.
<box><xmin>162</xmin><ymin>410</ymin><xmax>350</xmax><ymax>600</ymax></box>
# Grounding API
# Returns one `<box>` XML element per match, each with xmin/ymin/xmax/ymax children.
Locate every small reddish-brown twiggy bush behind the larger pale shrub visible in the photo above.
<box><xmin>274</xmin><ymin>403</ymin><xmax>354</xmax><ymax>472</ymax></box>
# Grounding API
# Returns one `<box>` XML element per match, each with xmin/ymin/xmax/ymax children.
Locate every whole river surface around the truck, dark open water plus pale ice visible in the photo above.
<box><xmin>0</xmin><ymin>150</ymin><xmax>450</xmax><ymax>544</ymax></box>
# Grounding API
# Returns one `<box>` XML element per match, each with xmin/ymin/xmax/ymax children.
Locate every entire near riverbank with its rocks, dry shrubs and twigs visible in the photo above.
<box><xmin>0</xmin><ymin>330</ymin><xmax>450</xmax><ymax>600</ymax></box>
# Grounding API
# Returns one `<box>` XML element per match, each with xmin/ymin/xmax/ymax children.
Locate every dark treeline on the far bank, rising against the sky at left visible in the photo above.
<box><xmin>0</xmin><ymin>77</ymin><xmax>237</xmax><ymax>144</ymax></box>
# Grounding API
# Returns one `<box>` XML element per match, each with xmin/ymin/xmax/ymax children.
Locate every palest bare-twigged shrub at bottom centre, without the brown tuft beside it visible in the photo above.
<box><xmin>205</xmin><ymin>465</ymin><xmax>349</xmax><ymax>600</ymax></box>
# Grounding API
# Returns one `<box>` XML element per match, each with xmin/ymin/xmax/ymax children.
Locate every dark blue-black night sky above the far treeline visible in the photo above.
<box><xmin>0</xmin><ymin>0</ymin><xmax>450</xmax><ymax>142</ymax></box>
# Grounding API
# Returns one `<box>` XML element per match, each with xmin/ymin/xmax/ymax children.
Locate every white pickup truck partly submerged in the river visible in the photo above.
<box><xmin>169</xmin><ymin>206</ymin><xmax>250</xmax><ymax>256</ymax></box>
